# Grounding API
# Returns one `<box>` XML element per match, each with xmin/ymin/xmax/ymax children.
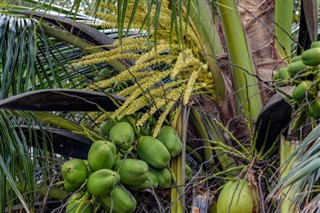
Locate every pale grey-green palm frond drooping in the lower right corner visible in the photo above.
<box><xmin>272</xmin><ymin>125</ymin><xmax>320</xmax><ymax>212</ymax></box>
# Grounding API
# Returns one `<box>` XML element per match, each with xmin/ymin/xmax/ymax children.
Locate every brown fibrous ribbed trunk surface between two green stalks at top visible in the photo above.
<box><xmin>238</xmin><ymin>0</ymin><xmax>285</xmax><ymax>102</ymax></box>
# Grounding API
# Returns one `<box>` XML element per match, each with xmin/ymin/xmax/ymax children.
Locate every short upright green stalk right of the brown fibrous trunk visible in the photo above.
<box><xmin>274</xmin><ymin>0</ymin><xmax>293</xmax><ymax>58</ymax></box>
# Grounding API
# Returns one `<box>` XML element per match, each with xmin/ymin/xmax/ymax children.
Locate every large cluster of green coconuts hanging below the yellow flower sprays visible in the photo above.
<box><xmin>61</xmin><ymin>121</ymin><xmax>182</xmax><ymax>213</ymax></box>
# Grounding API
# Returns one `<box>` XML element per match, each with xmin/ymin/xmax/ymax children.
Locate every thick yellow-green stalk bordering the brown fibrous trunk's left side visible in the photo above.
<box><xmin>216</xmin><ymin>0</ymin><xmax>262</xmax><ymax>119</ymax></box>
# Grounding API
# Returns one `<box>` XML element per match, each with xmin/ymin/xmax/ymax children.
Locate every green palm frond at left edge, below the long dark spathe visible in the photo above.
<box><xmin>0</xmin><ymin>110</ymin><xmax>47</xmax><ymax>212</ymax></box>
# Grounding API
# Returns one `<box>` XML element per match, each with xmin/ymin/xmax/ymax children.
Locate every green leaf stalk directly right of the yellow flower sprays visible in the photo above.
<box><xmin>190</xmin><ymin>0</ymin><xmax>225</xmax><ymax>103</ymax></box>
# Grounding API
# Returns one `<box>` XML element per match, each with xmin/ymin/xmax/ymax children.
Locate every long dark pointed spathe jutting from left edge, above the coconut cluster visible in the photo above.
<box><xmin>0</xmin><ymin>89</ymin><xmax>125</xmax><ymax>111</ymax></box>
